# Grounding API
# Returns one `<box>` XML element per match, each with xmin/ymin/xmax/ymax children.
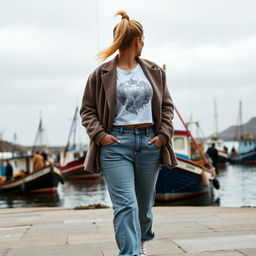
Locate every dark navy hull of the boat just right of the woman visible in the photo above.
<box><xmin>156</xmin><ymin>157</ymin><xmax>214</xmax><ymax>201</ymax></box>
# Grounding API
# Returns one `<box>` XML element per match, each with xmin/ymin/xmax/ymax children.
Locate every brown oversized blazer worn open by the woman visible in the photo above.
<box><xmin>80</xmin><ymin>55</ymin><xmax>178</xmax><ymax>173</ymax></box>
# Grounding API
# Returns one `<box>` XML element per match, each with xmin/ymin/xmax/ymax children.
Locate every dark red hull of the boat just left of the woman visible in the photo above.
<box><xmin>60</xmin><ymin>159</ymin><xmax>100</xmax><ymax>179</ymax></box>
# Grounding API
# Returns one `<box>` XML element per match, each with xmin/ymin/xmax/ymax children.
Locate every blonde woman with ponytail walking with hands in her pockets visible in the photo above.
<box><xmin>80</xmin><ymin>11</ymin><xmax>177</xmax><ymax>256</ymax></box>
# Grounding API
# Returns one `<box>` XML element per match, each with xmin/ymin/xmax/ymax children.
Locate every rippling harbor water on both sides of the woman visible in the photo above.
<box><xmin>0</xmin><ymin>164</ymin><xmax>256</xmax><ymax>208</ymax></box>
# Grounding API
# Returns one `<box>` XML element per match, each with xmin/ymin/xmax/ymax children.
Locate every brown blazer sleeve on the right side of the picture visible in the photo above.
<box><xmin>158</xmin><ymin>69</ymin><xmax>174</xmax><ymax>144</ymax></box>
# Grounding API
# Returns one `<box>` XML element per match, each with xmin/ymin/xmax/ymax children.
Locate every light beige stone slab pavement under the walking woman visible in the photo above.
<box><xmin>0</xmin><ymin>207</ymin><xmax>256</xmax><ymax>256</ymax></box>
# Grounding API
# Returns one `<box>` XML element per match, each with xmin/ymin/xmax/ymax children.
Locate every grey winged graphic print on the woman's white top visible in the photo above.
<box><xmin>116</xmin><ymin>78</ymin><xmax>153</xmax><ymax>115</ymax></box>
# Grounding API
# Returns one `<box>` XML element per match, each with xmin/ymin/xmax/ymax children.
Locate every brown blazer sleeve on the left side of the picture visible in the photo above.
<box><xmin>80</xmin><ymin>72</ymin><xmax>107</xmax><ymax>145</ymax></box>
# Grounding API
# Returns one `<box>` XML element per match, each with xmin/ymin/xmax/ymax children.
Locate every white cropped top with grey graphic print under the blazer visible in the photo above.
<box><xmin>113</xmin><ymin>64</ymin><xmax>153</xmax><ymax>125</ymax></box>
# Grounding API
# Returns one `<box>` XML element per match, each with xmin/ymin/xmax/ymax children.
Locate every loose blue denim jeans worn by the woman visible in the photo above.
<box><xmin>100</xmin><ymin>126</ymin><xmax>161</xmax><ymax>256</ymax></box>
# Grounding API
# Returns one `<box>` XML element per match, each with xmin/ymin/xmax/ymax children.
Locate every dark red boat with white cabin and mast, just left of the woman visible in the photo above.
<box><xmin>60</xmin><ymin>107</ymin><xmax>100</xmax><ymax>179</ymax></box>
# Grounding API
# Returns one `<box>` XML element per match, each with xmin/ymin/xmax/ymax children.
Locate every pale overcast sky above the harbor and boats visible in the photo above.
<box><xmin>0</xmin><ymin>0</ymin><xmax>256</xmax><ymax>146</ymax></box>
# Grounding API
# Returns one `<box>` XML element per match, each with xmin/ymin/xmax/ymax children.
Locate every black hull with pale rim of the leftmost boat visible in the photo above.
<box><xmin>0</xmin><ymin>166</ymin><xmax>64</xmax><ymax>193</ymax></box>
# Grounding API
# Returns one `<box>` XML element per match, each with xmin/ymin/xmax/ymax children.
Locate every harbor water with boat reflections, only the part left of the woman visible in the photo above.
<box><xmin>0</xmin><ymin>177</ymin><xmax>111</xmax><ymax>208</ymax></box>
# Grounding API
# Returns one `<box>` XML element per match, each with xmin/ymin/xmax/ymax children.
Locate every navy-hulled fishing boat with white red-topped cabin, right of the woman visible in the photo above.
<box><xmin>156</xmin><ymin>105</ymin><xmax>219</xmax><ymax>201</ymax></box>
